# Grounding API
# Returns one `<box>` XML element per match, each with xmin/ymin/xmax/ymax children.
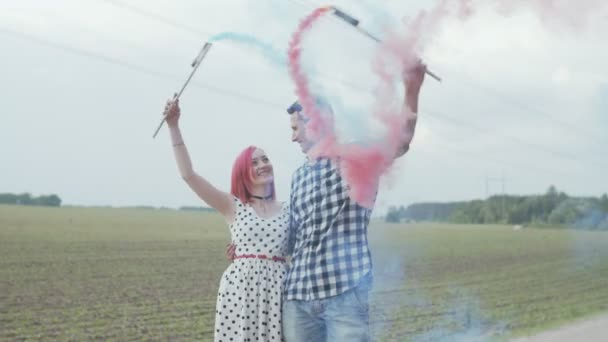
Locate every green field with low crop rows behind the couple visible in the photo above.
<box><xmin>0</xmin><ymin>206</ymin><xmax>608</xmax><ymax>341</ymax></box>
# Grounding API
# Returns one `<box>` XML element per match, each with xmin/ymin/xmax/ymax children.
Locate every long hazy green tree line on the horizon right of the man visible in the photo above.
<box><xmin>385</xmin><ymin>186</ymin><xmax>608</xmax><ymax>230</ymax></box>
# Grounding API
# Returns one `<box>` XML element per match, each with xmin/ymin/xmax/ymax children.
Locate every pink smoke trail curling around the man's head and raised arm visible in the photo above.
<box><xmin>288</xmin><ymin>0</ymin><xmax>608</xmax><ymax>207</ymax></box>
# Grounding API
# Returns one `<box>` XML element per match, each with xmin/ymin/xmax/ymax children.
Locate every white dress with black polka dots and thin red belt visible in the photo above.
<box><xmin>215</xmin><ymin>199</ymin><xmax>289</xmax><ymax>342</ymax></box>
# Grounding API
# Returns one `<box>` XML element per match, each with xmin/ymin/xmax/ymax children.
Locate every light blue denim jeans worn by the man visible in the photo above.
<box><xmin>283</xmin><ymin>275</ymin><xmax>371</xmax><ymax>342</ymax></box>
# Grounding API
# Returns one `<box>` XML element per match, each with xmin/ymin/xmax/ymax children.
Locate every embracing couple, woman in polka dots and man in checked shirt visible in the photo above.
<box><xmin>164</xmin><ymin>64</ymin><xmax>426</xmax><ymax>342</ymax></box>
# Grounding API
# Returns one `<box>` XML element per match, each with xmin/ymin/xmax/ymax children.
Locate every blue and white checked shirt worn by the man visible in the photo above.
<box><xmin>285</xmin><ymin>159</ymin><xmax>372</xmax><ymax>300</ymax></box>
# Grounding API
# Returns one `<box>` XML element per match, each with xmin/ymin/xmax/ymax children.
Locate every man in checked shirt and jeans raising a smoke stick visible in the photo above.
<box><xmin>283</xmin><ymin>63</ymin><xmax>426</xmax><ymax>342</ymax></box>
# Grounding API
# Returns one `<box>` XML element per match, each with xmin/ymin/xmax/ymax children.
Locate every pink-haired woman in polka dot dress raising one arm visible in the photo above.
<box><xmin>164</xmin><ymin>100</ymin><xmax>289</xmax><ymax>341</ymax></box>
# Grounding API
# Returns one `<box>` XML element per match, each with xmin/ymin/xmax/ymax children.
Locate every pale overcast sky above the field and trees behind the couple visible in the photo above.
<box><xmin>0</xmin><ymin>0</ymin><xmax>608</xmax><ymax>213</ymax></box>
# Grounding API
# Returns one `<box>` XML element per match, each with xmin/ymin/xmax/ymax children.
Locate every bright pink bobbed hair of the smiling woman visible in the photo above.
<box><xmin>230</xmin><ymin>146</ymin><xmax>276</xmax><ymax>203</ymax></box>
